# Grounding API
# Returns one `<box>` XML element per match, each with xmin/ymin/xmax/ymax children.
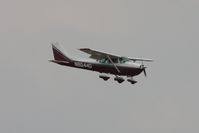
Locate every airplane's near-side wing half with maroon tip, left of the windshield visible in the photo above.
<box><xmin>79</xmin><ymin>48</ymin><xmax>120</xmax><ymax>60</ymax></box>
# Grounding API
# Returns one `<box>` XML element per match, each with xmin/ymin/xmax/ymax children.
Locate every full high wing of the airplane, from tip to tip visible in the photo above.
<box><xmin>79</xmin><ymin>48</ymin><xmax>153</xmax><ymax>62</ymax></box>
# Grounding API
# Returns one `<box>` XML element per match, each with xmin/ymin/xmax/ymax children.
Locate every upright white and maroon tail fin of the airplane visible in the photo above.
<box><xmin>52</xmin><ymin>43</ymin><xmax>72</xmax><ymax>62</ymax></box>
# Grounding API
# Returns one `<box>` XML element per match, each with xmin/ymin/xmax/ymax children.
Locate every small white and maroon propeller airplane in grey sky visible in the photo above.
<box><xmin>49</xmin><ymin>43</ymin><xmax>153</xmax><ymax>84</ymax></box>
